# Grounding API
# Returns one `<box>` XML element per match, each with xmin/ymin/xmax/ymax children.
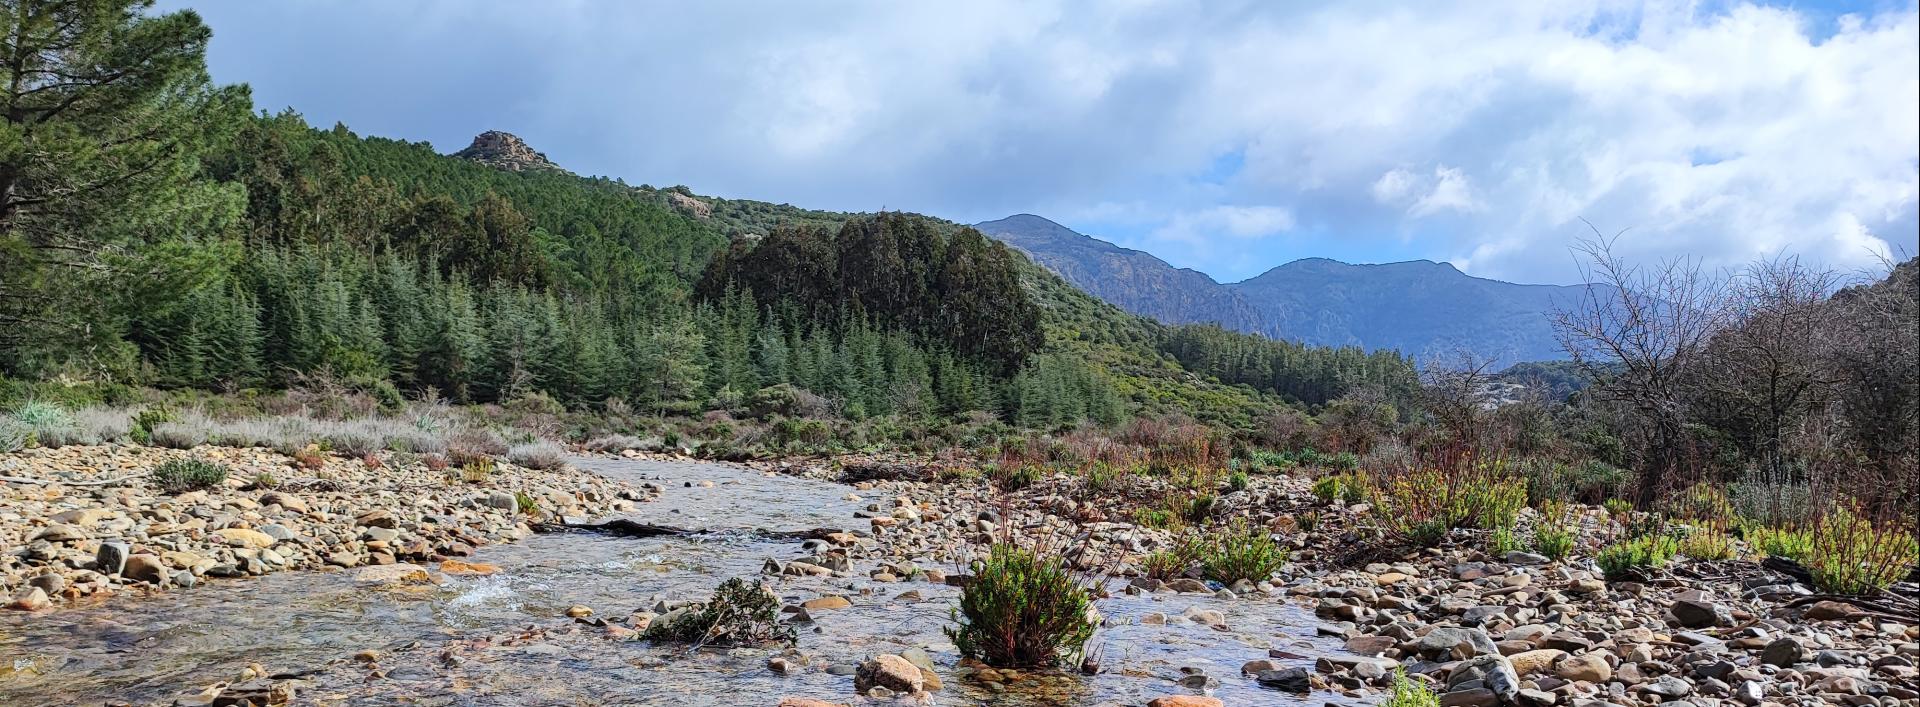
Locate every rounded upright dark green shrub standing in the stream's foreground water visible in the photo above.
<box><xmin>945</xmin><ymin>544</ymin><xmax>1100</xmax><ymax>667</ymax></box>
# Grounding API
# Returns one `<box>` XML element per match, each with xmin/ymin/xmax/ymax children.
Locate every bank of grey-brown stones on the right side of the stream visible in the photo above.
<box><xmin>744</xmin><ymin>465</ymin><xmax>1920</xmax><ymax>707</ymax></box>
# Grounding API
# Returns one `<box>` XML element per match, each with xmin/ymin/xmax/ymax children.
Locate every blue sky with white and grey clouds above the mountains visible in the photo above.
<box><xmin>157</xmin><ymin>0</ymin><xmax>1920</xmax><ymax>282</ymax></box>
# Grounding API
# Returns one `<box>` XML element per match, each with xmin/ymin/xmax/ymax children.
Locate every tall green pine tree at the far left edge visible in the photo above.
<box><xmin>0</xmin><ymin>0</ymin><xmax>246</xmax><ymax>369</ymax></box>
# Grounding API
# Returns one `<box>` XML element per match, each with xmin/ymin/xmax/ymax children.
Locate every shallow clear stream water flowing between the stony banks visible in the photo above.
<box><xmin>0</xmin><ymin>459</ymin><xmax>1338</xmax><ymax>707</ymax></box>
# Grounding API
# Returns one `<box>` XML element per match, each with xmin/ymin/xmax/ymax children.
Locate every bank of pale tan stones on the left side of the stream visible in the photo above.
<box><xmin>0</xmin><ymin>446</ymin><xmax>655</xmax><ymax>611</ymax></box>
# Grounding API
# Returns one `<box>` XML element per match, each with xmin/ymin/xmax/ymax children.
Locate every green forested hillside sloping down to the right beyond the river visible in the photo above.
<box><xmin>0</xmin><ymin>4</ymin><xmax>1413</xmax><ymax>425</ymax></box>
